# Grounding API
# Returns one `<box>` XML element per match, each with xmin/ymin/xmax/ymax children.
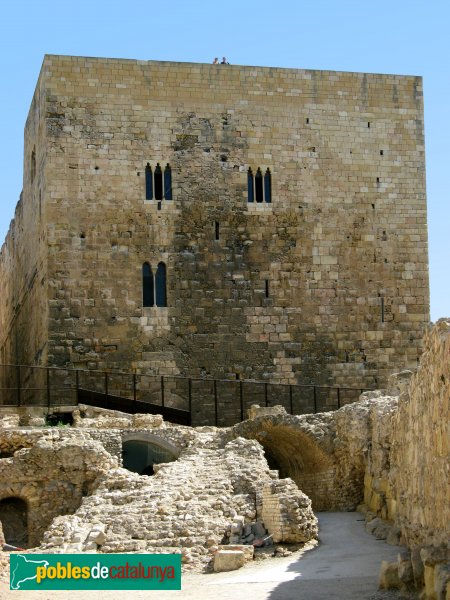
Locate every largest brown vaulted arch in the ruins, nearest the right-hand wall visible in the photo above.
<box><xmin>246</xmin><ymin>421</ymin><xmax>335</xmax><ymax>510</ymax></box>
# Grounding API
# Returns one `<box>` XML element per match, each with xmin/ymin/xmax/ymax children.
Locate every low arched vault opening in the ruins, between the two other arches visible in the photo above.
<box><xmin>122</xmin><ymin>433</ymin><xmax>179</xmax><ymax>475</ymax></box>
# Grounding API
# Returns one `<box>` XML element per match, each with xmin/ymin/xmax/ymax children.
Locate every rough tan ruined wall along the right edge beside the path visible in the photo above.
<box><xmin>365</xmin><ymin>319</ymin><xmax>450</xmax><ymax>600</ymax></box>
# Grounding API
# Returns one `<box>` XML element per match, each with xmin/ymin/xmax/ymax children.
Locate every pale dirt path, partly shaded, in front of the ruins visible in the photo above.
<box><xmin>0</xmin><ymin>513</ymin><xmax>414</xmax><ymax>600</ymax></box>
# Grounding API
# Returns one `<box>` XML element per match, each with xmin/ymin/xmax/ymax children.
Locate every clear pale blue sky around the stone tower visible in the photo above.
<box><xmin>0</xmin><ymin>0</ymin><xmax>450</xmax><ymax>321</ymax></box>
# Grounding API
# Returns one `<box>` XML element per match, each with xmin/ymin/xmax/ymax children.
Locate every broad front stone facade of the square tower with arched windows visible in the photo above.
<box><xmin>0</xmin><ymin>56</ymin><xmax>428</xmax><ymax>388</ymax></box>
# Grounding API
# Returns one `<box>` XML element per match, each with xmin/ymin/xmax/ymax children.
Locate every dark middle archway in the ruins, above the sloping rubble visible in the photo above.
<box><xmin>122</xmin><ymin>439</ymin><xmax>177</xmax><ymax>475</ymax></box>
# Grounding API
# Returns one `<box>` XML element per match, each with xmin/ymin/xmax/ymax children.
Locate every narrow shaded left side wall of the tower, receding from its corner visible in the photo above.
<box><xmin>0</xmin><ymin>69</ymin><xmax>49</xmax><ymax>370</ymax></box>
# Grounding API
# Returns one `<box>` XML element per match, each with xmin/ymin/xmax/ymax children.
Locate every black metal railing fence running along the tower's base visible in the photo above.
<box><xmin>0</xmin><ymin>365</ymin><xmax>365</xmax><ymax>426</ymax></box>
